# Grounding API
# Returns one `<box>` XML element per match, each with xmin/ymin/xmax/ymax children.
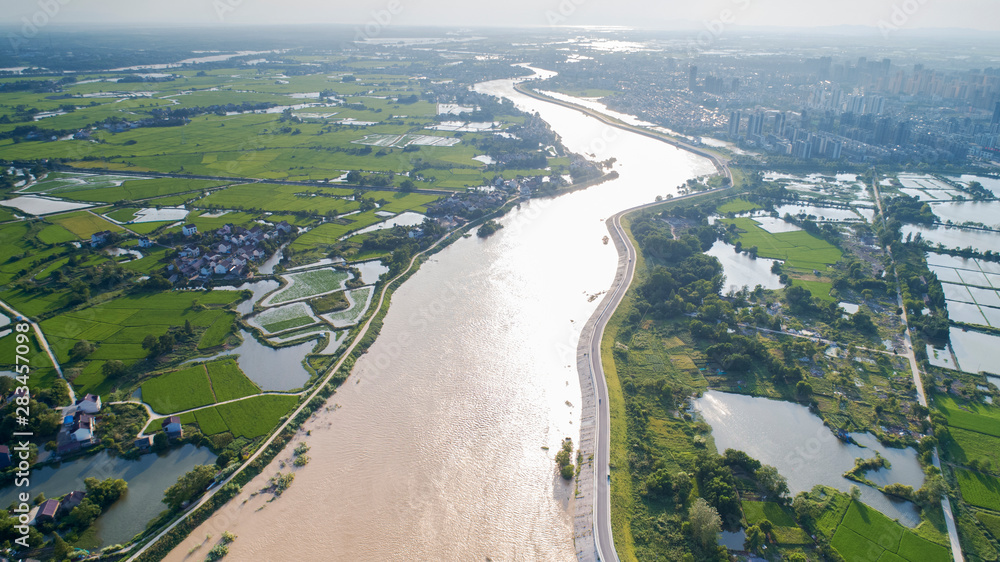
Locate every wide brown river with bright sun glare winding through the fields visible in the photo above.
<box><xmin>168</xmin><ymin>71</ymin><xmax>715</xmax><ymax>561</ymax></box>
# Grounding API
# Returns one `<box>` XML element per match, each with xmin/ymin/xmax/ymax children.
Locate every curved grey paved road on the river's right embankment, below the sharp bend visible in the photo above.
<box><xmin>577</xmin><ymin>188</ymin><xmax>729</xmax><ymax>562</ymax></box>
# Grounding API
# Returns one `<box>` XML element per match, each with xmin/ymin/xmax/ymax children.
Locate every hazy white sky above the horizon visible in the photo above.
<box><xmin>0</xmin><ymin>0</ymin><xmax>1000</xmax><ymax>31</ymax></box>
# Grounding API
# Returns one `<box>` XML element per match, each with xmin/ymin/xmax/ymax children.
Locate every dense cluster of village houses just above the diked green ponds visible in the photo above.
<box><xmin>167</xmin><ymin>221</ymin><xmax>293</xmax><ymax>283</ymax></box>
